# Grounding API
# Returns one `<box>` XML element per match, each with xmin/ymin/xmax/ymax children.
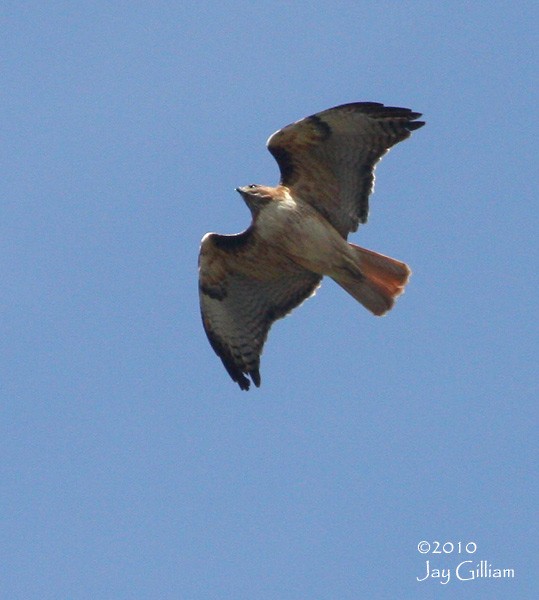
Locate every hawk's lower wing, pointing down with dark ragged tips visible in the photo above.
<box><xmin>199</xmin><ymin>228</ymin><xmax>321</xmax><ymax>390</ymax></box>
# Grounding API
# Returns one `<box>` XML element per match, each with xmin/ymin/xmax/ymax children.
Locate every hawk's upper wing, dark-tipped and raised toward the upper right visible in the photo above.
<box><xmin>268</xmin><ymin>102</ymin><xmax>425</xmax><ymax>238</ymax></box>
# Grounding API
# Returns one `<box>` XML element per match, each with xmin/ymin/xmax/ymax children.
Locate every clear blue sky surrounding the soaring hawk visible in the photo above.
<box><xmin>0</xmin><ymin>0</ymin><xmax>539</xmax><ymax>600</ymax></box>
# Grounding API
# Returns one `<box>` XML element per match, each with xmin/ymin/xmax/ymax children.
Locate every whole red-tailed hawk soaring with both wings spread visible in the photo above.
<box><xmin>199</xmin><ymin>102</ymin><xmax>425</xmax><ymax>390</ymax></box>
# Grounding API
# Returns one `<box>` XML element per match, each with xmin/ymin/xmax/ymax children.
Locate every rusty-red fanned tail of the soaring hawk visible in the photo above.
<box><xmin>332</xmin><ymin>244</ymin><xmax>411</xmax><ymax>316</ymax></box>
